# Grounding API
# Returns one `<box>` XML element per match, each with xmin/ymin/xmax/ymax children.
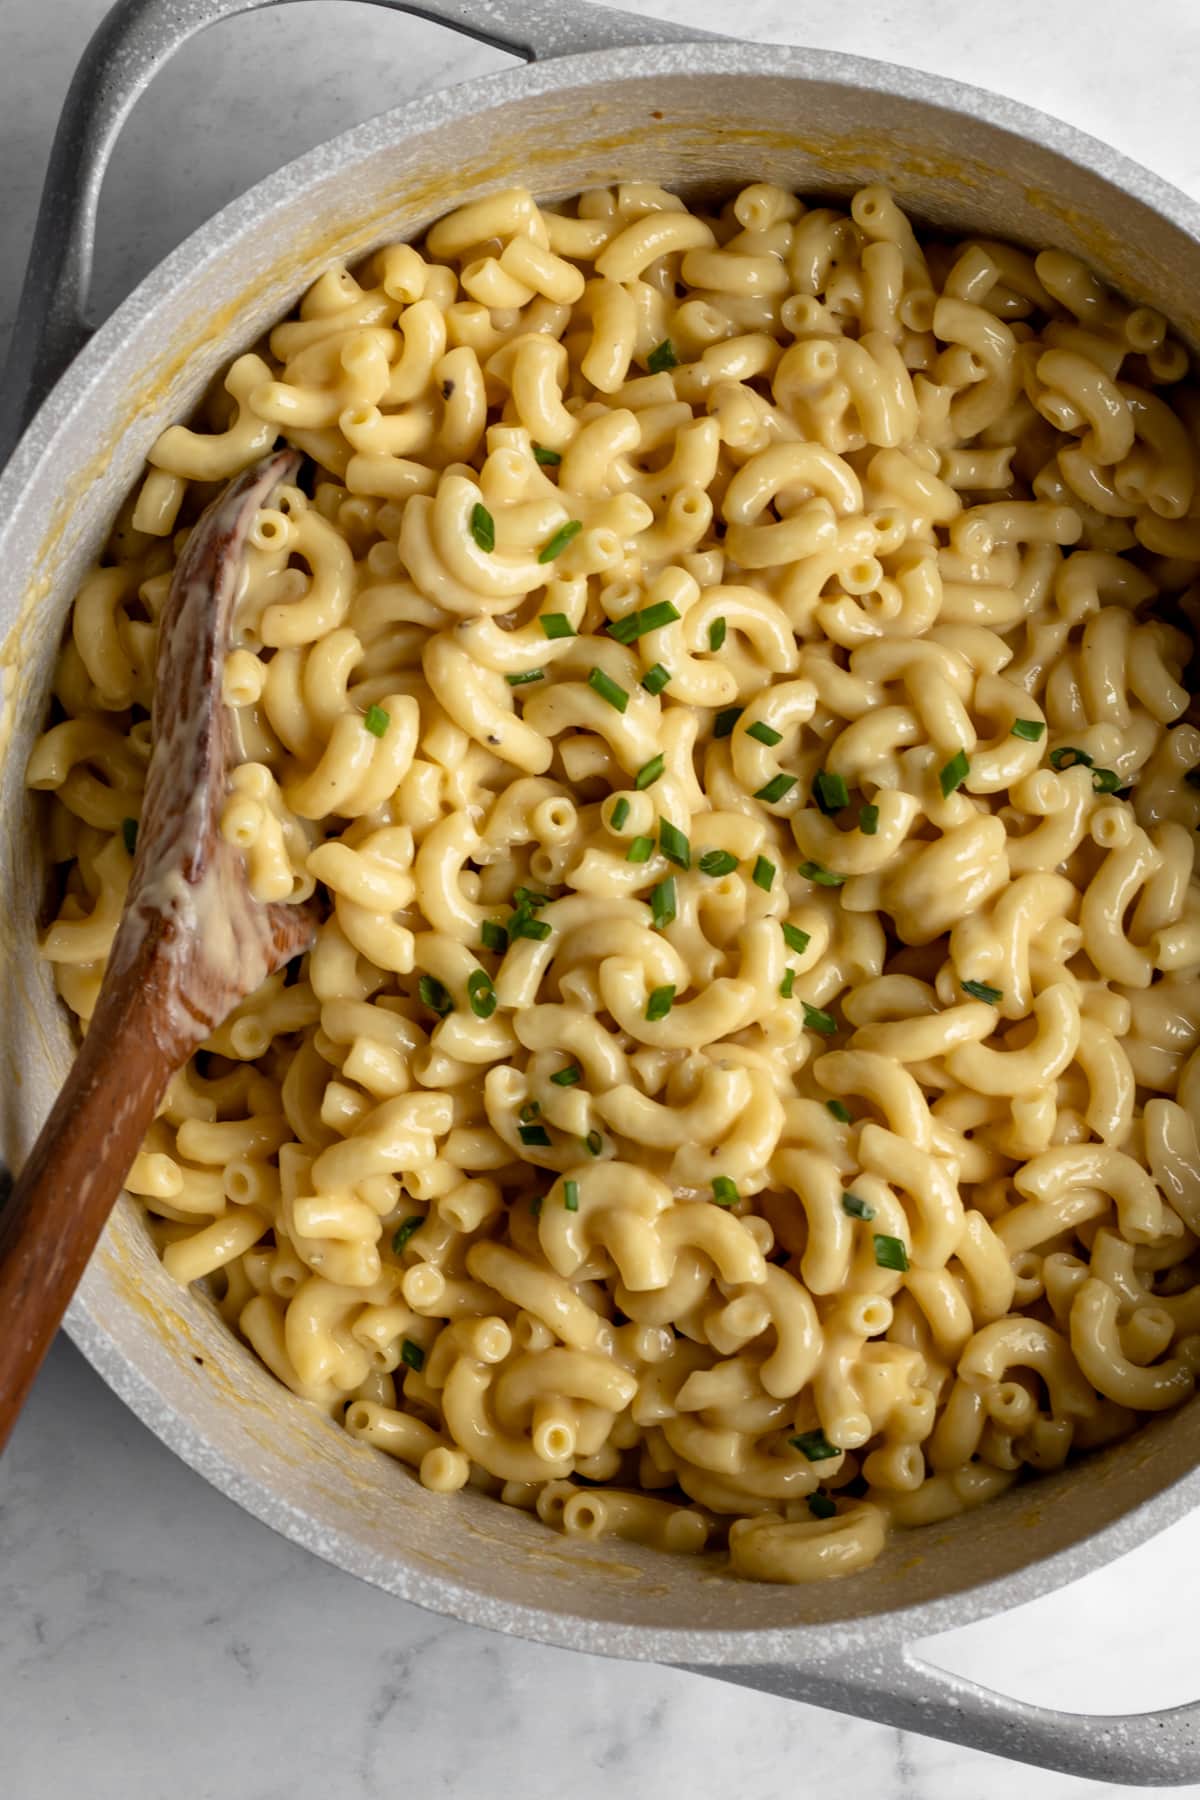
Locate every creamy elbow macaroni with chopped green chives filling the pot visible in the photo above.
<box><xmin>29</xmin><ymin>182</ymin><xmax>1200</xmax><ymax>1582</ymax></box>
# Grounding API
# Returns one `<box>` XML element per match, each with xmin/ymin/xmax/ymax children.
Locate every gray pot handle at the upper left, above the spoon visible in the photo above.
<box><xmin>0</xmin><ymin>0</ymin><xmax>712</xmax><ymax>442</ymax></box>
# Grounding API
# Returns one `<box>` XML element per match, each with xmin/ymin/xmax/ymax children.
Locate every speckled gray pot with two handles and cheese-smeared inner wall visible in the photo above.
<box><xmin>0</xmin><ymin>0</ymin><xmax>1200</xmax><ymax>1786</ymax></box>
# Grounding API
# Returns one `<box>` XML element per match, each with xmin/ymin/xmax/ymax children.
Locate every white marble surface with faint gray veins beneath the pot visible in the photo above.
<box><xmin>0</xmin><ymin>0</ymin><xmax>1200</xmax><ymax>1800</ymax></box>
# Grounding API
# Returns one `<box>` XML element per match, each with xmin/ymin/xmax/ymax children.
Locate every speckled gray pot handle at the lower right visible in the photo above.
<box><xmin>680</xmin><ymin>1643</ymin><xmax>1200</xmax><ymax>1787</ymax></box>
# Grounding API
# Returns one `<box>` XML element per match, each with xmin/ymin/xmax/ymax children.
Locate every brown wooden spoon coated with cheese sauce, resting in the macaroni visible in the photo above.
<box><xmin>0</xmin><ymin>450</ymin><xmax>315</xmax><ymax>1449</ymax></box>
